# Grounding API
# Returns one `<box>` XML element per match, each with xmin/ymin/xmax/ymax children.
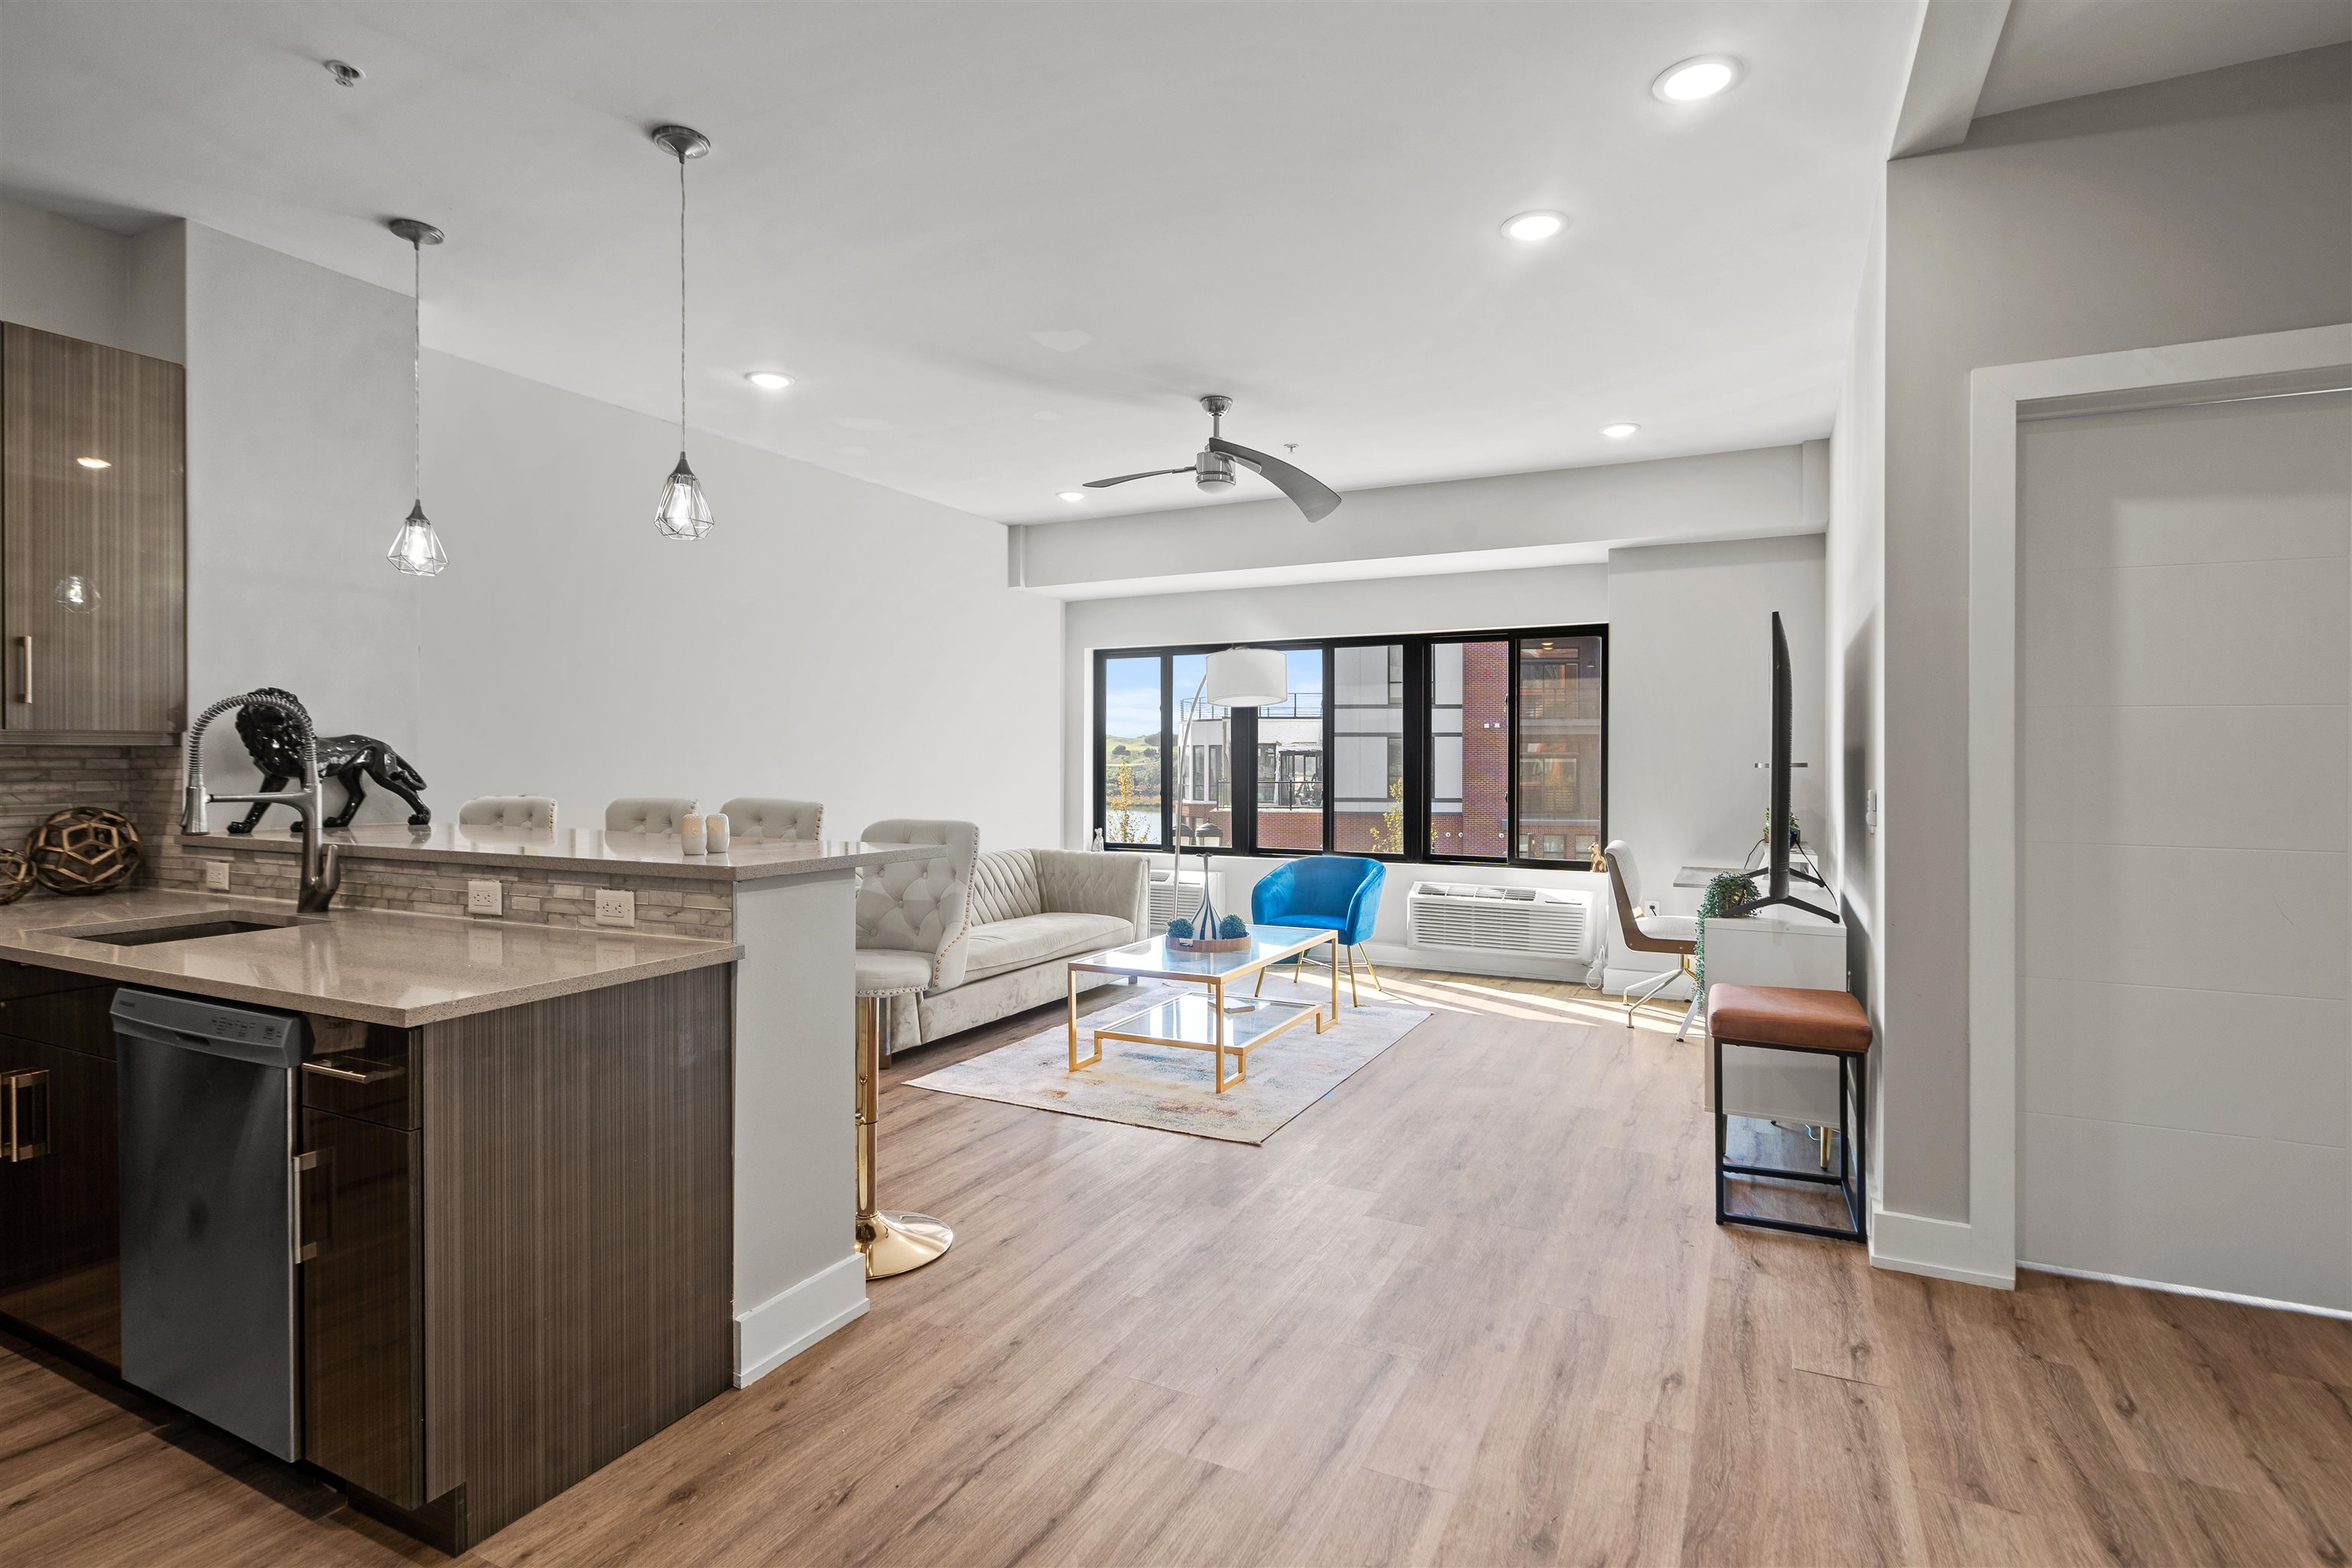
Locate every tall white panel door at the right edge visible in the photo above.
<box><xmin>2018</xmin><ymin>393</ymin><xmax>2352</xmax><ymax>1309</ymax></box>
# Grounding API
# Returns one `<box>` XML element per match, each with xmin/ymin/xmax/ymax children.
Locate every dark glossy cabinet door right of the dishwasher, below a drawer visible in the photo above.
<box><xmin>301</xmin><ymin>1109</ymin><xmax>426</xmax><ymax>1507</ymax></box>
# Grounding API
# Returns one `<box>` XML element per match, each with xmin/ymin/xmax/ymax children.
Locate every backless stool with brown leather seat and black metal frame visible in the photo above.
<box><xmin>1707</xmin><ymin>985</ymin><xmax>1870</xmax><ymax>1241</ymax></box>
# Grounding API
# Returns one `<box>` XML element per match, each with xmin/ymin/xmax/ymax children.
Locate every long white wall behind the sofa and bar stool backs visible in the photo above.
<box><xmin>413</xmin><ymin>350</ymin><xmax>1063</xmax><ymax>848</ymax></box>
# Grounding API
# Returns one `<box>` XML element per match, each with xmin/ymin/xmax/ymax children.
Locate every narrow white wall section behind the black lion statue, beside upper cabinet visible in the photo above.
<box><xmin>184</xmin><ymin>224</ymin><xmax>428</xmax><ymax>825</ymax></box>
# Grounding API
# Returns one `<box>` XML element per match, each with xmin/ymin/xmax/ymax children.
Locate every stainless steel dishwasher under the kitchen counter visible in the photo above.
<box><xmin>113</xmin><ymin>988</ymin><xmax>308</xmax><ymax>1460</ymax></box>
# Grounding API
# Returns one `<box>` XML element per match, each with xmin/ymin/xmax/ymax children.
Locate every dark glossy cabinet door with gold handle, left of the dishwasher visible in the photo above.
<box><xmin>0</xmin><ymin>1034</ymin><xmax>122</xmax><ymax>1366</ymax></box>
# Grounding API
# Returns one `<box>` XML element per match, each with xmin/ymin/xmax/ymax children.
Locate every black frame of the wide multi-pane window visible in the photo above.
<box><xmin>1086</xmin><ymin>621</ymin><xmax>1613</xmax><ymax>870</ymax></box>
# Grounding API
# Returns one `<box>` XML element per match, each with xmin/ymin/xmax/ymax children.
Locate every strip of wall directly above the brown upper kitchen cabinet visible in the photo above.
<box><xmin>0</xmin><ymin>198</ymin><xmax>184</xmax><ymax>360</ymax></box>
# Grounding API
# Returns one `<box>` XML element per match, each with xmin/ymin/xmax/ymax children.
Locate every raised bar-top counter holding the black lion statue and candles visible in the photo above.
<box><xmin>178</xmin><ymin>823</ymin><xmax>948</xmax><ymax>881</ymax></box>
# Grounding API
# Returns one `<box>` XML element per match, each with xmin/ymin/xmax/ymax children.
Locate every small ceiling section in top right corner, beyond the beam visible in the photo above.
<box><xmin>1975</xmin><ymin>0</ymin><xmax>2352</xmax><ymax>115</ymax></box>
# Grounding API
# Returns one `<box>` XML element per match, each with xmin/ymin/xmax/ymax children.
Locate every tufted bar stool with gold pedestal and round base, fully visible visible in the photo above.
<box><xmin>856</xmin><ymin>818</ymin><xmax>981</xmax><ymax>1279</ymax></box>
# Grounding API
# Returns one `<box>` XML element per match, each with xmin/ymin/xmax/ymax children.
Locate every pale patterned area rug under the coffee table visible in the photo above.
<box><xmin>910</xmin><ymin>980</ymin><xmax>1428</xmax><ymax>1142</ymax></box>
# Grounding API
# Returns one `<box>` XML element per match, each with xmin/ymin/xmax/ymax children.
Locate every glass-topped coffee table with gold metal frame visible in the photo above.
<box><xmin>1070</xmin><ymin>926</ymin><xmax>1338</xmax><ymax>1093</ymax></box>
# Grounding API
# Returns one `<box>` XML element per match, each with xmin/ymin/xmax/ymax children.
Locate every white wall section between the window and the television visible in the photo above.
<box><xmin>1609</xmin><ymin>534</ymin><xmax>1828</xmax><ymax>914</ymax></box>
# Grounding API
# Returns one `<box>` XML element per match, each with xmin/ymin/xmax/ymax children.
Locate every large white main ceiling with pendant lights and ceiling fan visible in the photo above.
<box><xmin>0</xmin><ymin>0</ymin><xmax>1919</xmax><ymax>522</ymax></box>
